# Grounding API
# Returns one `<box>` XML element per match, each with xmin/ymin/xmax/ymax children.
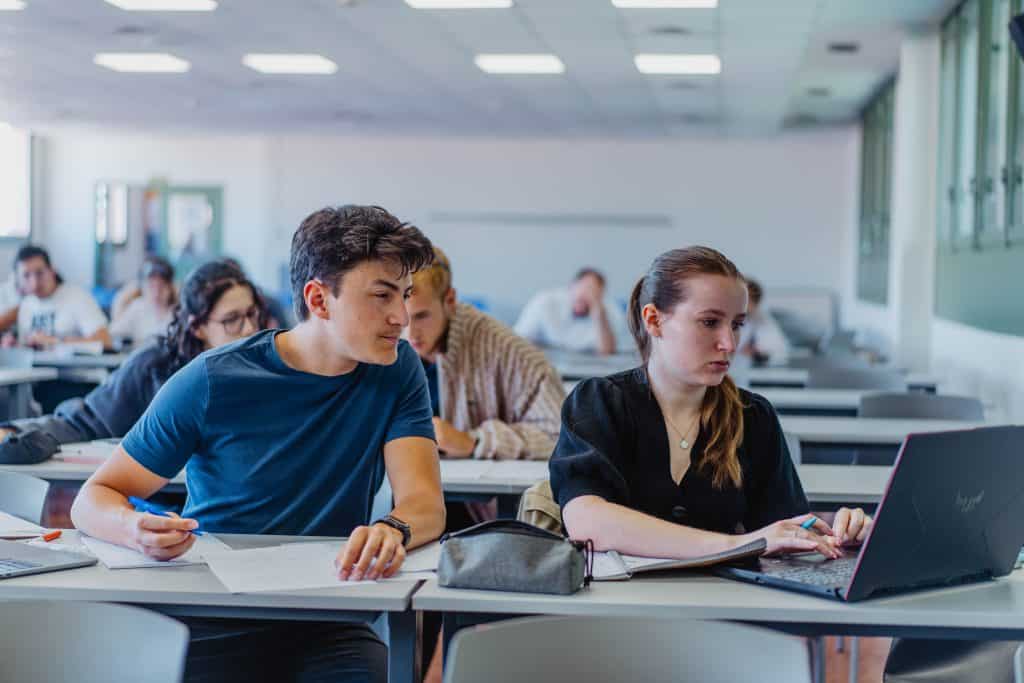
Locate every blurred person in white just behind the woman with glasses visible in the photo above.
<box><xmin>111</xmin><ymin>256</ymin><xmax>178</xmax><ymax>346</ymax></box>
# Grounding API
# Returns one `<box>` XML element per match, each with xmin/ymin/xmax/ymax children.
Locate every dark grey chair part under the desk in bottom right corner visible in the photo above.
<box><xmin>882</xmin><ymin>638</ymin><xmax>1021</xmax><ymax>683</ymax></box>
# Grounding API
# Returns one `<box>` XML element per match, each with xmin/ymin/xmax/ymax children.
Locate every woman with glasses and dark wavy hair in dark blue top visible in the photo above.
<box><xmin>0</xmin><ymin>261</ymin><xmax>265</xmax><ymax>464</ymax></box>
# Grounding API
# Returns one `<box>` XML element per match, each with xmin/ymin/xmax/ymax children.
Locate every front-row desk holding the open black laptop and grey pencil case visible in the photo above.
<box><xmin>413</xmin><ymin>570</ymin><xmax>1024</xmax><ymax>667</ymax></box>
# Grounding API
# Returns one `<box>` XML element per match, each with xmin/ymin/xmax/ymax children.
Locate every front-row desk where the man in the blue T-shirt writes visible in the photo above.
<box><xmin>0</xmin><ymin>530</ymin><xmax>421</xmax><ymax>683</ymax></box>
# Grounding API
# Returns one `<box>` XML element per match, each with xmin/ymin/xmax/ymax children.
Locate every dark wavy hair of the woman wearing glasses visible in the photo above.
<box><xmin>161</xmin><ymin>260</ymin><xmax>267</xmax><ymax>373</ymax></box>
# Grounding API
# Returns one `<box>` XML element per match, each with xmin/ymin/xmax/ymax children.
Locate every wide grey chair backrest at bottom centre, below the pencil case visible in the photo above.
<box><xmin>444</xmin><ymin>616</ymin><xmax>811</xmax><ymax>683</ymax></box>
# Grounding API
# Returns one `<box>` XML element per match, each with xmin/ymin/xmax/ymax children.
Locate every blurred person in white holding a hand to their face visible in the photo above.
<box><xmin>515</xmin><ymin>268</ymin><xmax>626</xmax><ymax>354</ymax></box>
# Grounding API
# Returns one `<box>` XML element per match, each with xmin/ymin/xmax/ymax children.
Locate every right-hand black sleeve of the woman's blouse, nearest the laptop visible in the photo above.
<box><xmin>743</xmin><ymin>394</ymin><xmax>810</xmax><ymax>531</ymax></box>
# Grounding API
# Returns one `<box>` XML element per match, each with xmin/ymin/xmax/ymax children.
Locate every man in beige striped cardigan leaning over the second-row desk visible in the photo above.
<box><xmin>407</xmin><ymin>247</ymin><xmax>565</xmax><ymax>460</ymax></box>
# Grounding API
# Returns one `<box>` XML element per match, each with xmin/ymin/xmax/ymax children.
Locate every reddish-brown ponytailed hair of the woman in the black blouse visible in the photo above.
<box><xmin>629</xmin><ymin>247</ymin><xmax>744</xmax><ymax>488</ymax></box>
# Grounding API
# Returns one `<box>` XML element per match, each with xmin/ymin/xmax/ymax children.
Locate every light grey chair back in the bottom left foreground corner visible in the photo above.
<box><xmin>0</xmin><ymin>600</ymin><xmax>188</xmax><ymax>683</ymax></box>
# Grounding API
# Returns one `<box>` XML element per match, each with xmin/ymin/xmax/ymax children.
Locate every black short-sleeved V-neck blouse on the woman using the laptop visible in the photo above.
<box><xmin>549</xmin><ymin>368</ymin><xmax>809</xmax><ymax>533</ymax></box>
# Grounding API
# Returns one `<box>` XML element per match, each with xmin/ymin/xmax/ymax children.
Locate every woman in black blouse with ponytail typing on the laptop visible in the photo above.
<box><xmin>550</xmin><ymin>247</ymin><xmax>871</xmax><ymax>558</ymax></box>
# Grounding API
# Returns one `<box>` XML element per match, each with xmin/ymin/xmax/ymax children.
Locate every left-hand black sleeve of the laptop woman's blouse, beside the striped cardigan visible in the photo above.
<box><xmin>548</xmin><ymin>378</ymin><xmax>633</xmax><ymax>507</ymax></box>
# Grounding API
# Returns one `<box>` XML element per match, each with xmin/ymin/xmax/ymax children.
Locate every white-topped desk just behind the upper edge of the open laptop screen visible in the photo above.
<box><xmin>779</xmin><ymin>415</ymin><xmax>992</xmax><ymax>465</ymax></box>
